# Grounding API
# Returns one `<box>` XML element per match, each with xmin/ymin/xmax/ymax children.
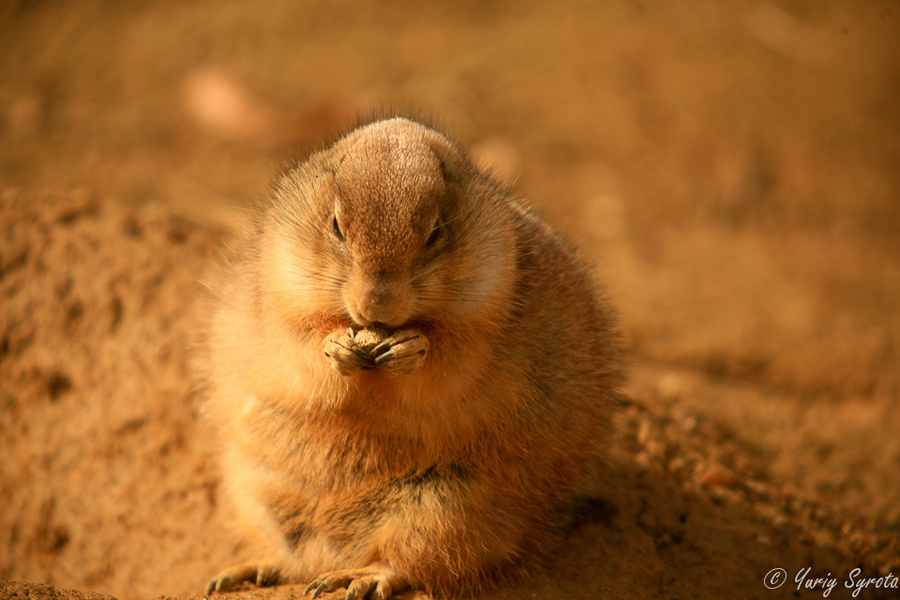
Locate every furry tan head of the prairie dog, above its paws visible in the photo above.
<box><xmin>258</xmin><ymin>118</ymin><xmax>515</xmax><ymax>327</ymax></box>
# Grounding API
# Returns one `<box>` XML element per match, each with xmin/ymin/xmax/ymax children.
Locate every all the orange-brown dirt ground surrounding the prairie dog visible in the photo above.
<box><xmin>0</xmin><ymin>0</ymin><xmax>900</xmax><ymax>600</ymax></box>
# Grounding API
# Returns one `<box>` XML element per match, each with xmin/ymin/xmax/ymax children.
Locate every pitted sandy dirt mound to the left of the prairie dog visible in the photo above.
<box><xmin>0</xmin><ymin>190</ymin><xmax>231</xmax><ymax>597</ymax></box>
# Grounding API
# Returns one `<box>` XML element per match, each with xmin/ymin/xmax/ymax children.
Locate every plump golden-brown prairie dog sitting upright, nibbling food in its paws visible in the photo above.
<box><xmin>206</xmin><ymin>118</ymin><xmax>621</xmax><ymax>598</ymax></box>
